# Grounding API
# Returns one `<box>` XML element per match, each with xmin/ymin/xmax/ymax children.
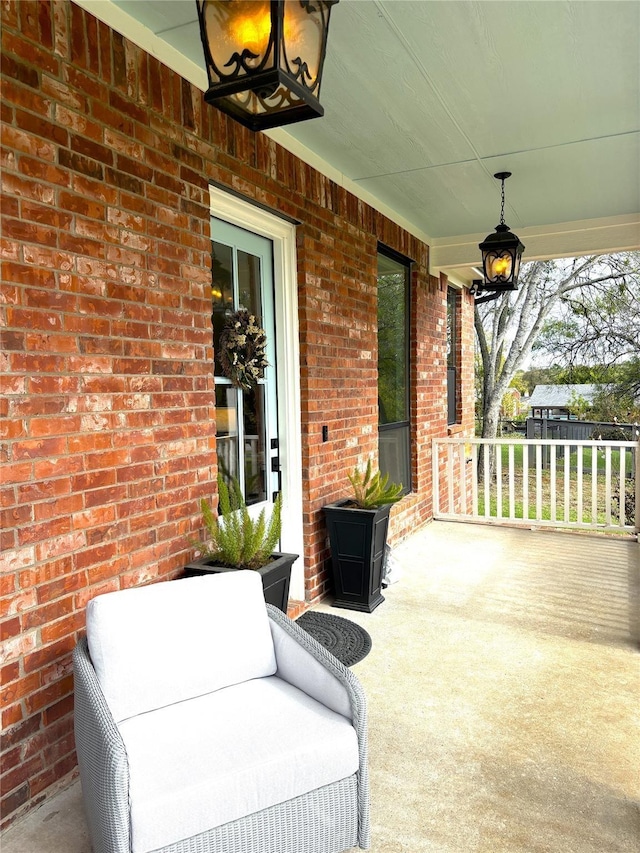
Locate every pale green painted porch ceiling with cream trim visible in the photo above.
<box><xmin>80</xmin><ymin>0</ymin><xmax>640</xmax><ymax>281</ymax></box>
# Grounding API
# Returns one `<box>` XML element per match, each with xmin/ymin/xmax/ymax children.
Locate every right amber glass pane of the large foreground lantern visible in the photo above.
<box><xmin>282</xmin><ymin>0</ymin><xmax>324</xmax><ymax>90</ymax></box>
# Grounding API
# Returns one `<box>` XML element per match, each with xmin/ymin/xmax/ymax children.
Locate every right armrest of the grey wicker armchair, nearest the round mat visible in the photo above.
<box><xmin>267</xmin><ymin>604</ymin><xmax>371</xmax><ymax>849</ymax></box>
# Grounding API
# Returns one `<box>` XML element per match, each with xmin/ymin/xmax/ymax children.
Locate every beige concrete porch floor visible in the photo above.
<box><xmin>2</xmin><ymin>522</ymin><xmax>640</xmax><ymax>853</ymax></box>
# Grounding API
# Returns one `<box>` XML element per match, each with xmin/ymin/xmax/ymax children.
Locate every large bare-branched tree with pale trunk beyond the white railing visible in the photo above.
<box><xmin>475</xmin><ymin>252</ymin><xmax>640</xmax><ymax>438</ymax></box>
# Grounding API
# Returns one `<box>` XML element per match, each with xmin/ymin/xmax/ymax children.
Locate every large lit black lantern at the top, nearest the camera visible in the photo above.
<box><xmin>196</xmin><ymin>0</ymin><xmax>338</xmax><ymax>131</ymax></box>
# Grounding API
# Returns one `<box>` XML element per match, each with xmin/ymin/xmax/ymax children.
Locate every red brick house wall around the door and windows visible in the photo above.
<box><xmin>0</xmin><ymin>0</ymin><xmax>473</xmax><ymax>823</ymax></box>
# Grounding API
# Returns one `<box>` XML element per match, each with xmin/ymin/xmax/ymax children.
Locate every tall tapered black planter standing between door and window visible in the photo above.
<box><xmin>324</xmin><ymin>500</ymin><xmax>391</xmax><ymax>613</ymax></box>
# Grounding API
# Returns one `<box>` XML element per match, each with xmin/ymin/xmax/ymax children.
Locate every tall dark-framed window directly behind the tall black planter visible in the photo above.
<box><xmin>378</xmin><ymin>250</ymin><xmax>411</xmax><ymax>492</ymax></box>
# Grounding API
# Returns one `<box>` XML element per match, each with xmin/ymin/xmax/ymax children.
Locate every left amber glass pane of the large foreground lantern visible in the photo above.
<box><xmin>204</xmin><ymin>0</ymin><xmax>273</xmax><ymax>77</ymax></box>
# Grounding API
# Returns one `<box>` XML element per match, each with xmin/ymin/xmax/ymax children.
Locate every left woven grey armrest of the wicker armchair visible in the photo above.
<box><xmin>73</xmin><ymin>638</ymin><xmax>131</xmax><ymax>853</ymax></box>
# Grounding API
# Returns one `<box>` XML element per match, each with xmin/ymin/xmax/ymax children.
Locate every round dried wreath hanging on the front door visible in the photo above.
<box><xmin>220</xmin><ymin>308</ymin><xmax>269</xmax><ymax>391</ymax></box>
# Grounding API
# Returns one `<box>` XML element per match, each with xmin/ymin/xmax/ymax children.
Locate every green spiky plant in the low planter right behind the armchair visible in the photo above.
<box><xmin>192</xmin><ymin>474</ymin><xmax>282</xmax><ymax>569</ymax></box>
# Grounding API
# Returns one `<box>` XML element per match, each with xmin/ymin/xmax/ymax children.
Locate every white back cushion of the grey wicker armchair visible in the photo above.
<box><xmin>87</xmin><ymin>571</ymin><xmax>276</xmax><ymax>721</ymax></box>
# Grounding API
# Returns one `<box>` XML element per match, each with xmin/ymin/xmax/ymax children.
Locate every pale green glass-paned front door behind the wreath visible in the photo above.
<box><xmin>211</xmin><ymin>218</ymin><xmax>279</xmax><ymax>506</ymax></box>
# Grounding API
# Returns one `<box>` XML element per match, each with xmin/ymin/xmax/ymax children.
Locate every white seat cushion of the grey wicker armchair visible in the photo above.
<box><xmin>119</xmin><ymin>676</ymin><xmax>358</xmax><ymax>853</ymax></box>
